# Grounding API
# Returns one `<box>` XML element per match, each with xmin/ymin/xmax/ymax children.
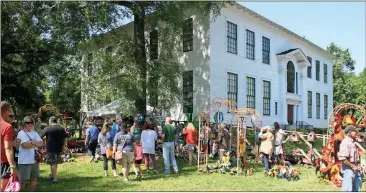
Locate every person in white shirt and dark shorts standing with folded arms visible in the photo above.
<box><xmin>17</xmin><ymin>116</ymin><xmax>43</xmax><ymax>192</ymax></box>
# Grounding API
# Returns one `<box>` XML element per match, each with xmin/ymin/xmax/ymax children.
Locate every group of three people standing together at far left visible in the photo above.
<box><xmin>1</xmin><ymin>101</ymin><xmax>67</xmax><ymax>192</ymax></box>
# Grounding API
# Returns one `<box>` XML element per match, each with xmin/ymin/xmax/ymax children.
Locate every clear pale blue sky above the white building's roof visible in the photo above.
<box><xmin>238</xmin><ymin>1</ymin><xmax>366</xmax><ymax>74</ymax></box>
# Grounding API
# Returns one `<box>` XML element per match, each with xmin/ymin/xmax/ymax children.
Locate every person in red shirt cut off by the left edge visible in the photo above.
<box><xmin>0</xmin><ymin>101</ymin><xmax>18</xmax><ymax>192</ymax></box>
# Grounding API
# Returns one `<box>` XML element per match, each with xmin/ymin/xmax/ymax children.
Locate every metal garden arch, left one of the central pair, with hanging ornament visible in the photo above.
<box><xmin>197</xmin><ymin>98</ymin><xmax>237</xmax><ymax>170</ymax></box>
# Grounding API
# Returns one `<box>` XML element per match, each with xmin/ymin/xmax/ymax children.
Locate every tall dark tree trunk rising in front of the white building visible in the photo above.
<box><xmin>133</xmin><ymin>1</ymin><xmax>147</xmax><ymax>115</ymax></box>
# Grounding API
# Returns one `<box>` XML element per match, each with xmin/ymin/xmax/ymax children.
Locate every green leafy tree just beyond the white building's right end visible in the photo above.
<box><xmin>327</xmin><ymin>43</ymin><xmax>357</xmax><ymax>107</ymax></box>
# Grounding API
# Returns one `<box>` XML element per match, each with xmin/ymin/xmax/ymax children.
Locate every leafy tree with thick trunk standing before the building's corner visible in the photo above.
<box><xmin>84</xmin><ymin>1</ymin><xmax>229</xmax><ymax>114</ymax></box>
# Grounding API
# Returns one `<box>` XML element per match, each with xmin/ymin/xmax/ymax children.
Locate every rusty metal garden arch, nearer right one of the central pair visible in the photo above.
<box><xmin>233</xmin><ymin>108</ymin><xmax>262</xmax><ymax>175</ymax></box>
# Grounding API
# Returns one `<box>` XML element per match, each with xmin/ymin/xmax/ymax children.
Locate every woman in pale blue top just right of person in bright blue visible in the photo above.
<box><xmin>98</xmin><ymin>123</ymin><xmax>118</xmax><ymax>176</ymax></box>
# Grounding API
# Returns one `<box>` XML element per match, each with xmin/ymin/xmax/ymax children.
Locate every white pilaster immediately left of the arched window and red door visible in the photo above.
<box><xmin>279</xmin><ymin>61</ymin><xmax>287</xmax><ymax>124</ymax></box>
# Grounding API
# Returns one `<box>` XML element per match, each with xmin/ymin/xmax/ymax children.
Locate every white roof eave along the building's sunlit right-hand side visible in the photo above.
<box><xmin>234</xmin><ymin>2</ymin><xmax>334</xmax><ymax>59</ymax></box>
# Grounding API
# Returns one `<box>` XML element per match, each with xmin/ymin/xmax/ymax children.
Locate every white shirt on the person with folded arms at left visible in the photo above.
<box><xmin>17</xmin><ymin>130</ymin><xmax>42</xmax><ymax>164</ymax></box>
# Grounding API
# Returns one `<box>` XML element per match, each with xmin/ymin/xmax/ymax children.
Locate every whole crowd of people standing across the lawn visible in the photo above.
<box><xmin>1</xmin><ymin>101</ymin><xmax>362</xmax><ymax>191</ymax></box>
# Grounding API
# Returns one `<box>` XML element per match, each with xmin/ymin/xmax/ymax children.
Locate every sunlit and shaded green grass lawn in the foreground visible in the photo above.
<box><xmin>33</xmin><ymin>155</ymin><xmax>366</xmax><ymax>192</ymax></box>
